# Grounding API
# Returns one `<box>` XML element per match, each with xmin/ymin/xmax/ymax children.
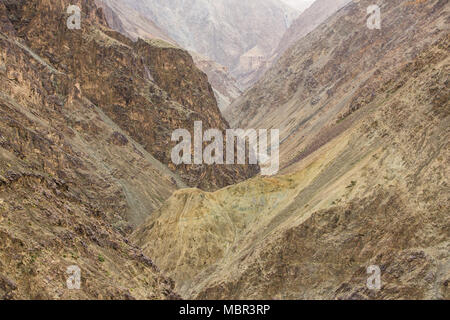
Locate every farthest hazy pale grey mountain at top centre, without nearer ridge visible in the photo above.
<box><xmin>108</xmin><ymin>0</ymin><xmax>298</xmax><ymax>89</ymax></box>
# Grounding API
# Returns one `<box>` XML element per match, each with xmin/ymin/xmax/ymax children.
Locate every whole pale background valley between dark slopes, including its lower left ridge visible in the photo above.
<box><xmin>97</xmin><ymin>0</ymin><xmax>303</xmax><ymax>110</ymax></box>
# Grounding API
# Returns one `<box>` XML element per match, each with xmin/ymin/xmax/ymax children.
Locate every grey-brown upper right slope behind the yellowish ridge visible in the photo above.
<box><xmin>229</xmin><ymin>1</ymin><xmax>447</xmax><ymax>172</ymax></box>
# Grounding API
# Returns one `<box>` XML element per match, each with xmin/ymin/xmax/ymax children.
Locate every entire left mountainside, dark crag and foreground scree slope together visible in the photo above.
<box><xmin>0</xmin><ymin>0</ymin><xmax>252</xmax><ymax>299</ymax></box>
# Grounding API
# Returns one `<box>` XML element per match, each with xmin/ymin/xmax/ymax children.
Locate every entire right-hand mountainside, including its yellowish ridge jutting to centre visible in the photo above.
<box><xmin>132</xmin><ymin>0</ymin><xmax>450</xmax><ymax>299</ymax></box>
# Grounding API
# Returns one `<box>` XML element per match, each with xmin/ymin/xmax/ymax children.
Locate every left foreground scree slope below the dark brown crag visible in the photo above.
<box><xmin>0</xmin><ymin>1</ymin><xmax>183</xmax><ymax>299</ymax></box>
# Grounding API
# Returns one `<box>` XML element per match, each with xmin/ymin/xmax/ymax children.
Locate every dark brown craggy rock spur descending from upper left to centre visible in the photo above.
<box><xmin>4</xmin><ymin>0</ymin><xmax>256</xmax><ymax>189</ymax></box>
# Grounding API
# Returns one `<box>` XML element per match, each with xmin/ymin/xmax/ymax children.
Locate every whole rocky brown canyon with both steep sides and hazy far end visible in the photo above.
<box><xmin>0</xmin><ymin>0</ymin><xmax>450</xmax><ymax>300</ymax></box>
